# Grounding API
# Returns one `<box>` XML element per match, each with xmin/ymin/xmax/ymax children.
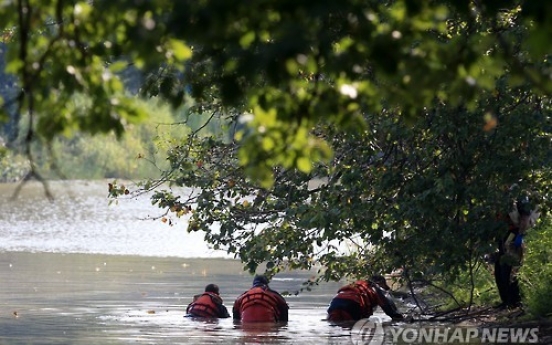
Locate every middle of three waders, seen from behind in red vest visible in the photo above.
<box><xmin>232</xmin><ymin>275</ymin><xmax>289</xmax><ymax>322</ymax></box>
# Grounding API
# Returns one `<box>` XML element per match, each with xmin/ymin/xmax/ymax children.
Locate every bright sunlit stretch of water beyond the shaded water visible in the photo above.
<box><xmin>0</xmin><ymin>181</ymin><xmax>230</xmax><ymax>257</ymax></box>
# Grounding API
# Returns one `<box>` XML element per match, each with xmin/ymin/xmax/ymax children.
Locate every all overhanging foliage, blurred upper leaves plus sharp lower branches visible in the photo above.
<box><xmin>0</xmin><ymin>0</ymin><xmax>552</xmax><ymax>296</ymax></box>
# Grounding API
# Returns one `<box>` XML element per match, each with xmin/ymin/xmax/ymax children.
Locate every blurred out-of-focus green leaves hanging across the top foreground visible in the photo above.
<box><xmin>0</xmin><ymin>0</ymin><xmax>552</xmax><ymax>186</ymax></box>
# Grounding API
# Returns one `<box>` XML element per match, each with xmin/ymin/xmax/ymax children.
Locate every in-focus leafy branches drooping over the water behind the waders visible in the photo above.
<box><xmin>134</xmin><ymin>79</ymin><xmax>552</xmax><ymax>281</ymax></box>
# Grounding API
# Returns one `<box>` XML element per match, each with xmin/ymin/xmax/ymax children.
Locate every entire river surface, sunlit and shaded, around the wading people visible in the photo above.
<box><xmin>0</xmin><ymin>181</ymin><xmax>388</xmax><ymax>345</ymax></box>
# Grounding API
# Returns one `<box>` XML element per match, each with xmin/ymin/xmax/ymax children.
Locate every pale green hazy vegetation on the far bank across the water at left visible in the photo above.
<box><xmin>0</xmin><ymin>98</ymin><xmax>229</xmax><ymax>182</ymax></box>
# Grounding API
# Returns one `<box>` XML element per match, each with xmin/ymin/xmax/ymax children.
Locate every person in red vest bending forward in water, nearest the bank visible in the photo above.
<box><xmin>327</xmin><ymin>276</ymin><xmax>404</xmax><ymax>322</ymax></box>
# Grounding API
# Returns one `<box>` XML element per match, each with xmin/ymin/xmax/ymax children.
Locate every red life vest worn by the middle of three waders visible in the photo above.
<box><xmin>234</xmin><ymin>286</ymin><xmax>287</xmax><ymax>322</ymax></box>
